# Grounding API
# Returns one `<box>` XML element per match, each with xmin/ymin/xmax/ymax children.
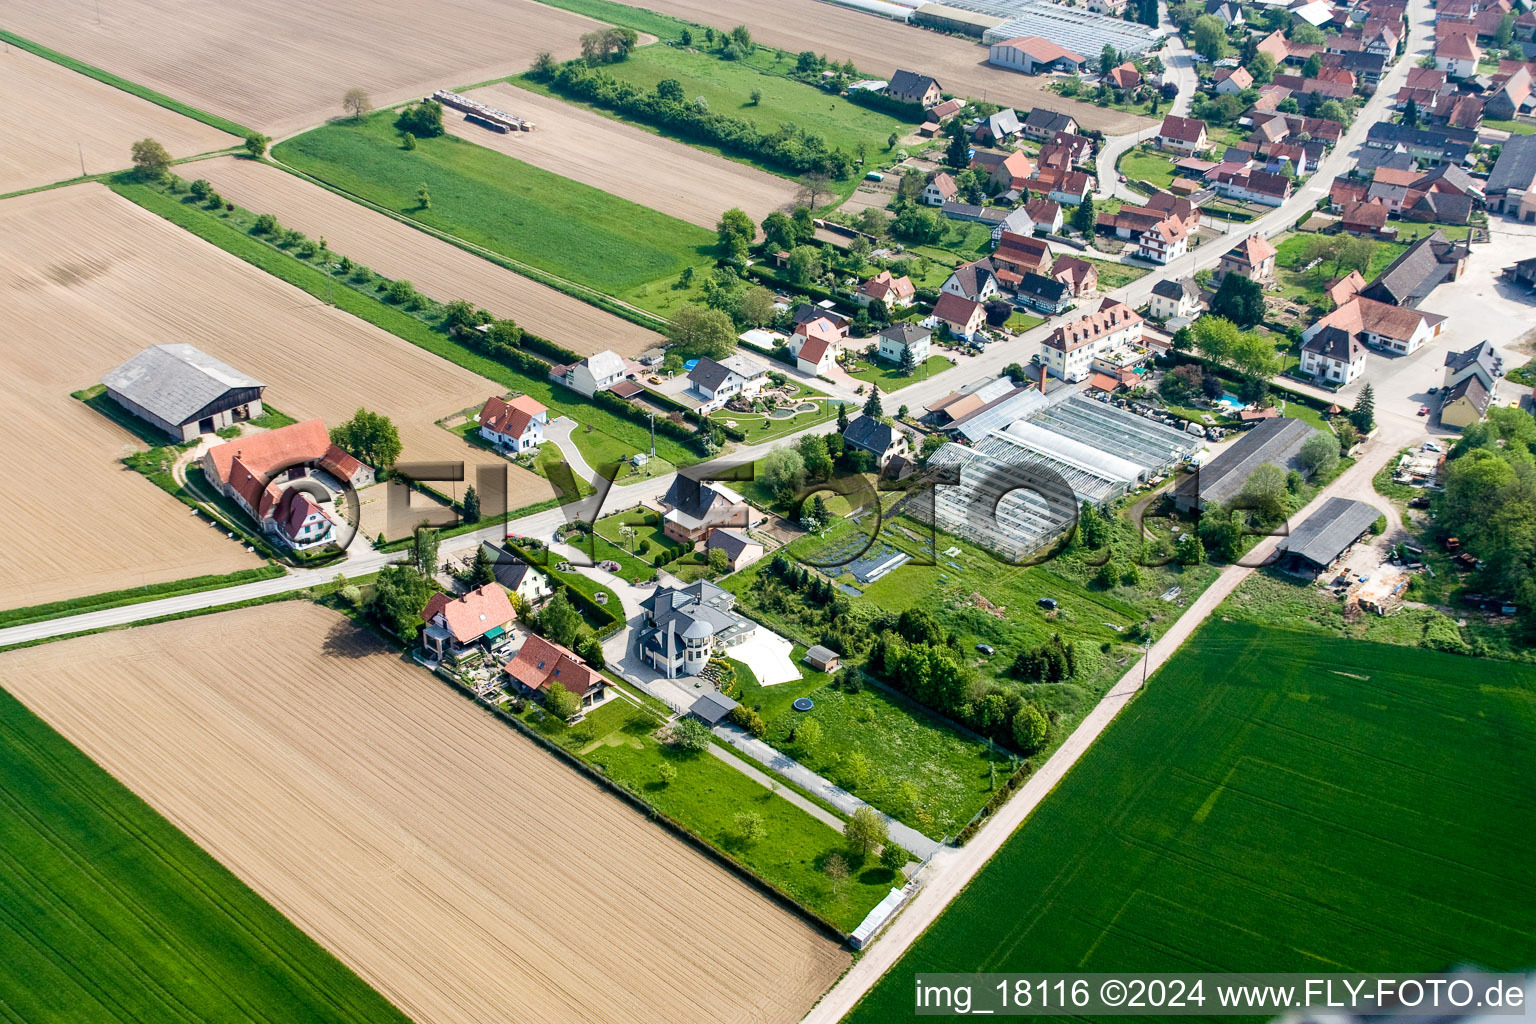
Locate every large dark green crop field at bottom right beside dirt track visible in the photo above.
<box><xmin>848</xmin><ymin>622</ymin><xmax>1536</xmax><ymax>1022</ymax></box>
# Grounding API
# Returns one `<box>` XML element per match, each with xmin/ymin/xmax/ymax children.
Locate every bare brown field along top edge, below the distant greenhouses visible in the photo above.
<box><xmin>599</xmin><ymin>0</ymin><xmax>1152</xmax><ymax>135</ymax></box>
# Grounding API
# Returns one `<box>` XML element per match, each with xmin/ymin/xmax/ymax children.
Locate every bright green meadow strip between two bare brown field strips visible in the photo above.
<box><xmin>273</xmin><ymin>111</ymin><xmax>714</xmax><ymax>312</ymax></box>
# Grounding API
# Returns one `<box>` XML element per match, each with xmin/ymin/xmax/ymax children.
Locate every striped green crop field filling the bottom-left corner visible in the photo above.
<box><xmin>0</xmin><ymin>692</ymin><xmax>407</xmax><ymax>1024</ymax></box>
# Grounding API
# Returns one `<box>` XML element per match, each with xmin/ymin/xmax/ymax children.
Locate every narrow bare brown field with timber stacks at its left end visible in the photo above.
<box><xmin>442</xmin><ymin>83</ymin><xmax>796</xmax><ymax>230</ymax></box>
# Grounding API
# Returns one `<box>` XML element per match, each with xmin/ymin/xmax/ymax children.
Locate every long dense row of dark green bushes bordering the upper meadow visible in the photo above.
<box><xmin>543</xmin><ymin>61</ymin><xmax>852</xmax><ymax>180</ymax></box>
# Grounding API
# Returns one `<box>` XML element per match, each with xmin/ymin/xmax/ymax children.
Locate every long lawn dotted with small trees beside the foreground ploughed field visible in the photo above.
<box><xmin>524</xmin><ymin>684</ymin><xmax>894</xmax><ymax>932</ymax></box>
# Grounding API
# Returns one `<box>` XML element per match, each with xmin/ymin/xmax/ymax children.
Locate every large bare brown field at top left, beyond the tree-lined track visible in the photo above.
<box><xmin>0</xmin><ymin>0</ymin><xmax>617</xmax><ymax>138</ymax></box>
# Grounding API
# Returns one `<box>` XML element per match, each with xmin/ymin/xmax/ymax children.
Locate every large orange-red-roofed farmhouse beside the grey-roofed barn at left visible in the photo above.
<box><xmin>203</xmin><ymin>419</ymin><xmax>373</xmax><ymax>550</ymax></box>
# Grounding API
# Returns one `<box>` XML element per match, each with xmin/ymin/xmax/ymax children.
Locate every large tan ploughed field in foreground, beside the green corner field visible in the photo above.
<box><xmin>0</xmin><ymin>602</ymin><xmax>848</xmax><ymax>1024</ymax></box>
